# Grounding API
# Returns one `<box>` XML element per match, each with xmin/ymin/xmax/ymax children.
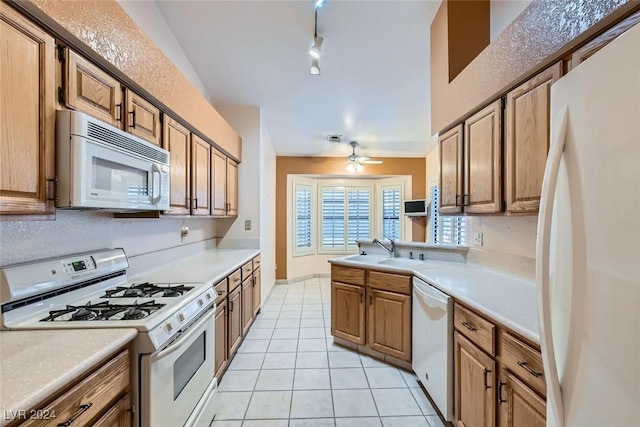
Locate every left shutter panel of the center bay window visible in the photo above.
<box><xmin>321</xmin><ymin>187</ymin><xmax>346</xmax><ymax>249</ymax></box>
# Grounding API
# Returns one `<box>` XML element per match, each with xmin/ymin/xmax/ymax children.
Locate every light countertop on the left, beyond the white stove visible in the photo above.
<box><xmin>129</xmin><ymin>249</ymin><xmax>260</xmax><ymax>284</ymax></box>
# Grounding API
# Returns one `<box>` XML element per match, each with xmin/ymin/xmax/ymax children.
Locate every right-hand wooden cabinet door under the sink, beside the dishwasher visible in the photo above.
<box><xmin>367</xmin><ymin>288</ymin><xmax>411</xmax><ymax>361</ymax></box>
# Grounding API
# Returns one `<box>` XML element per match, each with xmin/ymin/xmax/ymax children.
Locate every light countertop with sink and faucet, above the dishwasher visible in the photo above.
<box><xmin>330</xmin><ymin>255</ymin><xmax>540</xmax><ymax>344</ymax></box>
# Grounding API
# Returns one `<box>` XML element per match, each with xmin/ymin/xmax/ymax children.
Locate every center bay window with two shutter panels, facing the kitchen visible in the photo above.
<box><xmin>319</xmin><ymin>187</ymin><xmax>371</xmax><ymax>252</ymax></box>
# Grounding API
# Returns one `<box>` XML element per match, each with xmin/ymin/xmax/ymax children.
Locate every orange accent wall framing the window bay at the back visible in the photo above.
<box><xmin>276</xmin><ymin>156</ymin><xmax>427</xmax><ymax>279</ymax></box>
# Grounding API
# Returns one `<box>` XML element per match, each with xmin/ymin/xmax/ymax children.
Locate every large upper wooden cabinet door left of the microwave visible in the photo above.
<box><xmin>0</xmin><ymin>2</ymin><xmax>56</xmax><ymax>214</ymax></box>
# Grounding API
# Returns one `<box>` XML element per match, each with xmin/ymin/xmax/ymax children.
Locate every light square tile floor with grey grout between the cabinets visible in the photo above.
<box><xmin>198</xmin><ymin>278</ymin><xmax>443</xmax><ymax>427</ymax></box>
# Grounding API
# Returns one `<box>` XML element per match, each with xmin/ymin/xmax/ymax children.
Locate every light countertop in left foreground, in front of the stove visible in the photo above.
<box><xmin>0</xmin><ymin>328</ymin><xmax>137</xmax><ymax>426</ymax></box>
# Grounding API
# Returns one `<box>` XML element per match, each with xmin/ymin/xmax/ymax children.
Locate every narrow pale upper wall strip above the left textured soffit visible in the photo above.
<box><xmin>116</xmin><ymin>0</ymin><xmax>211</xmax><ymax>103</ymax></box>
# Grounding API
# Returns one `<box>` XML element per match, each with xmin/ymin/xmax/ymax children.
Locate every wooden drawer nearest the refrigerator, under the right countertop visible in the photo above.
<box><xmin>500</xmin><ymin>332</ymin><xmax>547</xmax><ymax>396</ymax></box>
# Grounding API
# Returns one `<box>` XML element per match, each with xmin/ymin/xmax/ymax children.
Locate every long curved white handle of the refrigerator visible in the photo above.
<box><xmin>536</xmin><ymin>106</ymin><xmax>568</xmax><ymax>427</ymax></box>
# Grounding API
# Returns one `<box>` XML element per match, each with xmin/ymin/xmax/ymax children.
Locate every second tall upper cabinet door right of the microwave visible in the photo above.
<box><xmin>191</xmin><ymin>135</ymin><xmax>211</xmax><ymax>215</ymax></box>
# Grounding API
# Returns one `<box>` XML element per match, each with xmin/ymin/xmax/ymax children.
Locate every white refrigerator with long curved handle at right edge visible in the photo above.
<box><xmin>536</xmin><ymin>21</ymin><xmax>640</xmax><ymax>427</ymax></box>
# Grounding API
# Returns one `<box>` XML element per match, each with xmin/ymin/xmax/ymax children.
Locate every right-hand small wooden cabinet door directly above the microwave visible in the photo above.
<box><xmin>124</xmin><ymin>89</ymin><xmax>162</xmax><ymax>146</ymax></box>
